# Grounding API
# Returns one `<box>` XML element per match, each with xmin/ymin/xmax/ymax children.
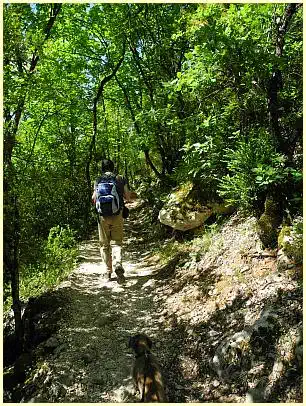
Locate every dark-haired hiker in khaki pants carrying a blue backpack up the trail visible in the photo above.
<box><xmin>92</xmin><ymin>159</ymin><xmax>130</xmax><ymax>282</ymax></box>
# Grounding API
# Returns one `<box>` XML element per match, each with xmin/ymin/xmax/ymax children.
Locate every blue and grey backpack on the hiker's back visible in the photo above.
<box><xmin>96</xmin><ymin>176</ymin><xmax>121</xmax><ymax>217</ymax></box>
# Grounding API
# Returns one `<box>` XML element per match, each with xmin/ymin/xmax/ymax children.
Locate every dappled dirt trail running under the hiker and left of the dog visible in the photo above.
<box><xmin>32</xmin><ymin>205</ymin><xmax>170</xmax><ymax>402</ymax></box>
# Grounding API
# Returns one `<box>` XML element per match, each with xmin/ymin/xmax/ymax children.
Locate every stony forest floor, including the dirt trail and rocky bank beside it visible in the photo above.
<box><xmin>4</xmin><ymin>198</ymin><xmax>302</xmax><ymax>403</ymax></box>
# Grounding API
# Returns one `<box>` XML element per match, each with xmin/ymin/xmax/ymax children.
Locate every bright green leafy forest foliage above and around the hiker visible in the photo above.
<box><xmin>4</xmin><ymin>3</ymin><xmax>303</xmax><ymax>308</ymax></box>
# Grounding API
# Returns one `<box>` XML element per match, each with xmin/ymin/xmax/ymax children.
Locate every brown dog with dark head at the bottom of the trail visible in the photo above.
<box><xmin>129</xmin><ymin>334</ymin><xmax>167</xmax><ymax>402</ymax></box>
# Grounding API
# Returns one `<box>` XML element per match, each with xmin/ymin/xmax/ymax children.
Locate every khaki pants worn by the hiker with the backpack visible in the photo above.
<box><xmin>98</xmin><ymin>213</ymin><xmax>123</xmax><ymax>272</ymax></box>
